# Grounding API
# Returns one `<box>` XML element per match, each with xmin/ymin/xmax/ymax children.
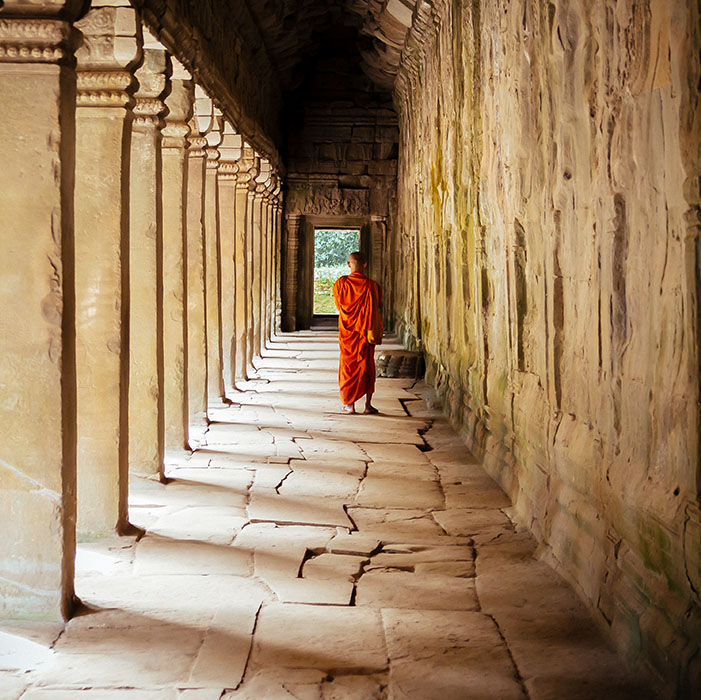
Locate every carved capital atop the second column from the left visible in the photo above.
<box><xmin>75</xmin><ymin>0</ymin><xmax>142</xmax><ymax>107</ymax></box>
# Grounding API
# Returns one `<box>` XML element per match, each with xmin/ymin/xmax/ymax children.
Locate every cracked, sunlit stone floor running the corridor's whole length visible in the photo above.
<box><xmin>0</xmin><ymin>333</ymin><xmax>649</xmax><ymax>700</ymax></box>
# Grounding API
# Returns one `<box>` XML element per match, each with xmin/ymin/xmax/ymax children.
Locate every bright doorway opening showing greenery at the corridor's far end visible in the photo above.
<box><xmin>313</xmin><ymin>228</ymin><xmax>360</xmax><ymax>317</ymax></box>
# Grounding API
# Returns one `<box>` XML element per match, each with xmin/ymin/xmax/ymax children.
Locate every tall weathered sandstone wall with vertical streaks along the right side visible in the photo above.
<box><xmin>392</xmin><ymin>0</ymin><xmax>701</xmax><ymax>697</ymax></box>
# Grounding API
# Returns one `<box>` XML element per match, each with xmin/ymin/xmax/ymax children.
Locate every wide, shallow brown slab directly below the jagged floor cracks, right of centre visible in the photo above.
<box><xmin>355</xmin><ymin>570</ymin><xmax>479</xmax><ymax>610</ymax></box>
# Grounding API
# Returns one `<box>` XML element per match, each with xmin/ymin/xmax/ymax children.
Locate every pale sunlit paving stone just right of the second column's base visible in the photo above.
<box><xmin>134</xmin><ymin>535</ymin><xmax>253</xmax><ymax>576</ymax></box>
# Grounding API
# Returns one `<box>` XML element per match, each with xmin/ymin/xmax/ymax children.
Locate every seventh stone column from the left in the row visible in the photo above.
<box><xmin>217</xmin><ymin>122</ymin><xmax>243</xmax><ymax>395</ymax></box>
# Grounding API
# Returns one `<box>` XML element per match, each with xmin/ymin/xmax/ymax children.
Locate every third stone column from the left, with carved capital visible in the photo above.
<box><xmin>129</xmin><ymin>43</ymin><xmax>170</xmax><ymax>475</ymax></box>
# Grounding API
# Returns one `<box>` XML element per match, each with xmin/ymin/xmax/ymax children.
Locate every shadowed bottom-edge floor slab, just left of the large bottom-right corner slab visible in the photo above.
<box><xmin>382</xmin><ymin>609</ymin><xmax>524</xmax><ymax>700</ymax></box>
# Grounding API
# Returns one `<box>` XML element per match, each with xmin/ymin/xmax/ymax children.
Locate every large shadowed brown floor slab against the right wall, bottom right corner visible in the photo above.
<box><xmin>477</xmin><ymin>533</ymin><xmax>649</xmax><ymax>700</ymax></box>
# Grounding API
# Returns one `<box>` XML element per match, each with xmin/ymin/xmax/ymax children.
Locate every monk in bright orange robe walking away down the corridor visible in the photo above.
<box><xmin>333</xmin><ymin>251</ymin><xmax>382</xmax><ymax>414</ymax></box>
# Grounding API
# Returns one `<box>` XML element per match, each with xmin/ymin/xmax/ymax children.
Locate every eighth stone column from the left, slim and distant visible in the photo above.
<box><xmin>235</xmin><ymin>144</ymin><xmax>258</xmax><ymax>379</ymax></box>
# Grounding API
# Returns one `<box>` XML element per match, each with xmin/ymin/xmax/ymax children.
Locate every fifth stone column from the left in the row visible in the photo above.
<box><xmin>185</xmin><ymin>112</ymin><xmax>207</xmax><ymax>430</ymax></box>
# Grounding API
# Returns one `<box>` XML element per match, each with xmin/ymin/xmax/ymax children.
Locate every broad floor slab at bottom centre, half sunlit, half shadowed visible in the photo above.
<box><xmin>250</xmin><ymin>604</ymin><xmax>387</xmax><ymax>674</ymax></box>
